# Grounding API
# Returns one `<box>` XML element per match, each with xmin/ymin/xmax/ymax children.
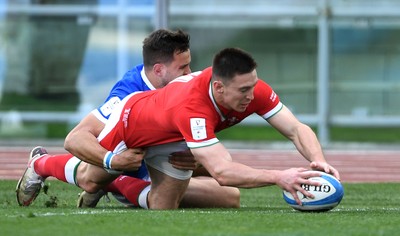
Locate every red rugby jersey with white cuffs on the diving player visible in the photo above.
<box><xmin>105</xmin><ymin>67</ymin><xmax>282</xmax><ymax>148</ymax></box>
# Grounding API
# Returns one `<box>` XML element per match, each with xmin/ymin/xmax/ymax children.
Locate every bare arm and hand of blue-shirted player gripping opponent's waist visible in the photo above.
<box><xmin>64</xmin><ymin>113</ymin><xmax>144</xmax><ymax>170</ymax></box>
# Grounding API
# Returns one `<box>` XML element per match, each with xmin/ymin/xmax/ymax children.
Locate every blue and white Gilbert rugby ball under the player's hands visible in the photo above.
<box><xmin>283</xmin><ymin>172</ymin><xmax>344</xmax><ymax>212</ymax></box>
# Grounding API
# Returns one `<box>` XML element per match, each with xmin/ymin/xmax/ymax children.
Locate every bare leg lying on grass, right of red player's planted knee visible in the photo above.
<box><xmin>179</xmin><ymin>176</ymin><xmax>240</xmax><ymax>208</ymax></box>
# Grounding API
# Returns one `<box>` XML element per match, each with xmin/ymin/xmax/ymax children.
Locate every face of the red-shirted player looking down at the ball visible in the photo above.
<box><xmin>221</xmin><ymin>70</ymin><xmax>258</xmax><ymax>112</ymax></box>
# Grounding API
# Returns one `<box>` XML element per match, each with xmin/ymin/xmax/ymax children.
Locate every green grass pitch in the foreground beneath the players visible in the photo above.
<box><xmin>0</xmin><ymin>180</ymin><xmax>400</xmax><ymax>236</ymax></box>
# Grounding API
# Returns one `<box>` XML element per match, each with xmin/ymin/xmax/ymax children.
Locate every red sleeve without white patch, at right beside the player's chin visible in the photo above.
<box><xmin>252</xmin><ymin>80</ymin><xmax>283</xmax><ymax>119</ymax></box>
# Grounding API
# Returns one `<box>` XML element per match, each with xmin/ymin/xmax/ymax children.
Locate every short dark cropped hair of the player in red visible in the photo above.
<box><xmin>212</xmin><ymin>48</ymin><xmax>257</xmax><ymax>81</ymax></box>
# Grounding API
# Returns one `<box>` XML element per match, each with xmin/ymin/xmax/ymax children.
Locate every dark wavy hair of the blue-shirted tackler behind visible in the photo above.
<box><xmin>142</xmin><ymin>29</ymin><xmax>190</xmax><ymax>67</ymax></box>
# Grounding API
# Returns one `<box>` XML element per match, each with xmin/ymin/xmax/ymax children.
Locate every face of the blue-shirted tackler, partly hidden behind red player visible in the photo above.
<box><xmin>163</xmin><ymin>50</ymin><xmax>192</xmax><ymax>85</ymax></box>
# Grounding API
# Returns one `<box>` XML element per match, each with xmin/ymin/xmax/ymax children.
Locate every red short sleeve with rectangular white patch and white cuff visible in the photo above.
<box><xmin>175</xmin><ymin>104</ymin><xmax>219</xmax><ymax>148</ymax></box>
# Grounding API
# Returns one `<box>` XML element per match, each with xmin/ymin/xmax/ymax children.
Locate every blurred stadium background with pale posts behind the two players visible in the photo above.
<box><xmin>0</xmin><ymin>0</ymin><xmax>400</xmax><ymax>145</ymax></box>
